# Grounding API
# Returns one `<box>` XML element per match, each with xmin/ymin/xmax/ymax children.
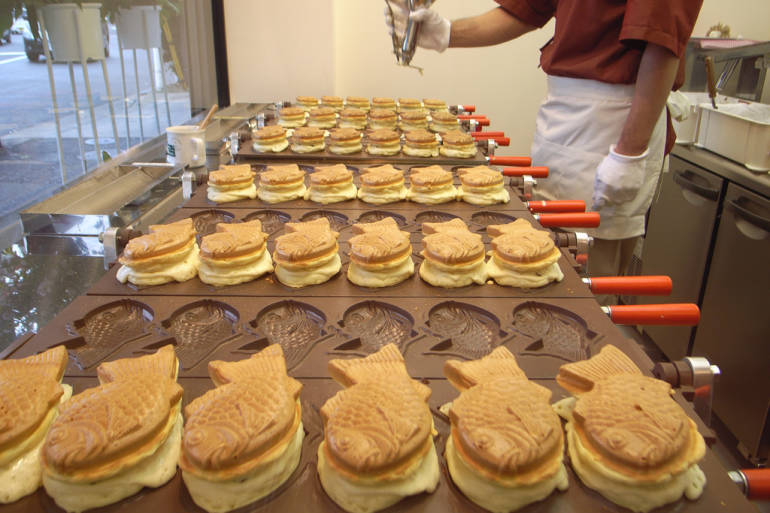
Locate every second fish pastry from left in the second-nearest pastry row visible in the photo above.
<box><xmin>198</xmin><ymin>219</ymin><xmax>273</xmax><ymax>286</ymax></box>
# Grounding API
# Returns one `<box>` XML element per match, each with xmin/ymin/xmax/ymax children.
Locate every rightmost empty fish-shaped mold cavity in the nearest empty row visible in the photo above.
<box><xmin>513</xmin><ymin>301</ymin><xmax>596</xmax><ymax>362</ymax></box>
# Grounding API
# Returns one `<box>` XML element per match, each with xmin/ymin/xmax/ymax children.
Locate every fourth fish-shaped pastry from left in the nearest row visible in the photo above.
<box><xmin>318</xmin><ymin>344</ymin><xmax>439</xmax><ymax>513</ymax></box>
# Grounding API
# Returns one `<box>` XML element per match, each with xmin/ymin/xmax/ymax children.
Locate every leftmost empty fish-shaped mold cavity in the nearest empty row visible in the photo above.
<box><xmin>71</xmin><ymin>299</ymin><xmax>154</xmax><ymax>369</ymax></box>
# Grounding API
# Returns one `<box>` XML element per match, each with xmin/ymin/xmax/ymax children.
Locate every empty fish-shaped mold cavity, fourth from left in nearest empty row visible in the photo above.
<box><xmin>337</xmin><ymin>301</ymin><xmax>415</xmax><ymax>353</ymax></box>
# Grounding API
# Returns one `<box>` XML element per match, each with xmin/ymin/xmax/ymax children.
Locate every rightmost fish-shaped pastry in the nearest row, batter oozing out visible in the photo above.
<box><xmin>554</xmin><ymin>345</ymin><xmax>706</xmax><ymax>513</ymax></box>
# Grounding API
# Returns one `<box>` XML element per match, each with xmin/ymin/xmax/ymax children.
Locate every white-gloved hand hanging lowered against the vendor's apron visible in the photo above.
<box><xmin>591</xmin><ymin>144</ymin><xmax>649</xmax><ymax>211</ymax></box>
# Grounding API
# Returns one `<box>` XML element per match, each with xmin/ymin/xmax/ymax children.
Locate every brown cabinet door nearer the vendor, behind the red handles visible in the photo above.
<box><xmin>639</xmin><ymin>156</ymin><xmax>724</xmax><ymax>360</ymax></box>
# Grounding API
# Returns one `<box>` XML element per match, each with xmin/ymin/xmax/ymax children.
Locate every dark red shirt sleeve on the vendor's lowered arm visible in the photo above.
<box><xmin>620</xmin><ymin>0</ymin><xmax>703</xmax><ymax>57</ymax></box>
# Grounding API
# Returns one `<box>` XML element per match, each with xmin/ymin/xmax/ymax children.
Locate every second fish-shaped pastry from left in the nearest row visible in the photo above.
<box><xmin>41</xmin><ymin>345</ymin><xmax>182</xmax><ymax>511</ymax></box>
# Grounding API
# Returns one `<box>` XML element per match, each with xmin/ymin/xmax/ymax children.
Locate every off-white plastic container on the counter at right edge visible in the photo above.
<box><xmin>696</xmin><ymin>102</ymin><xmax>770</xmax><ymax>172</ymax></box>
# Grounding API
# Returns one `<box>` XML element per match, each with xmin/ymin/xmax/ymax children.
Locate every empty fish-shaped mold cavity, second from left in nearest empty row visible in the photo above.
<box><xmin>162</xmin><ymin>299</ymin><xmax>239</xmax><ymax>369</ymax></box>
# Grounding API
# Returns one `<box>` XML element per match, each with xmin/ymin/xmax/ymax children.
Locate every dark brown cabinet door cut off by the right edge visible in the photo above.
<box><xmin>693</xmin><ymin>184</ymin><xmax>770</xmax><ymax>456</ymax></box>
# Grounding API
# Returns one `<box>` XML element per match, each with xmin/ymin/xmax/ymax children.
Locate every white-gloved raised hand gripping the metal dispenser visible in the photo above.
<box><xmin>385</xmin><ymin>0</ymin><xmax>452</xmax><ymax>52</ymax></box>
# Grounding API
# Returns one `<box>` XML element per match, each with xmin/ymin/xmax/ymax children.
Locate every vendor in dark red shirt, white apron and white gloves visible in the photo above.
<box><xmin>386</xmin><ymin>0</ymin><xmax>702</xmax><ymax>296</ymax></box>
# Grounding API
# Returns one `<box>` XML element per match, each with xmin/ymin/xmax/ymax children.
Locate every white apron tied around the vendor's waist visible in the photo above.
<box><xmin>532</xmin><ymin>76</ymin><xmax>666</xmax><ymax>239</ymax></box>
